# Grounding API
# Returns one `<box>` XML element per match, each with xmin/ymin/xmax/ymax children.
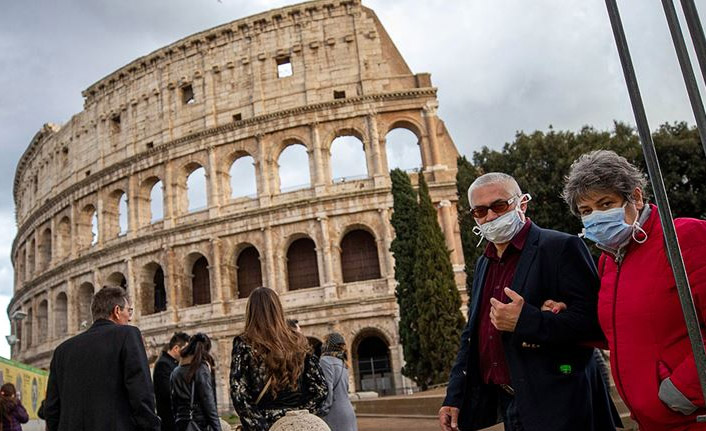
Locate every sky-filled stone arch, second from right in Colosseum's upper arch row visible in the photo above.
<box><xmin>327</xmin><ymin>128</ymin><xmax>371</xmax><ymax>183</ymax></box>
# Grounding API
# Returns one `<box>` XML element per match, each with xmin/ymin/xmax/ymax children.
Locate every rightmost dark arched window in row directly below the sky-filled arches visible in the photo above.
<box><xmin>341</xmin><ymin>229</ymin><xmax>380</xmax><ymax>283</ymax></box>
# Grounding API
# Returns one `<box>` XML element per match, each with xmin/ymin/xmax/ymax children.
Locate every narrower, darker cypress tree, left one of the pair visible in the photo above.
<box><xmin>390</xmin><ymin>169</ymin><xmax>423</xmax><ymax>384</ymax></box>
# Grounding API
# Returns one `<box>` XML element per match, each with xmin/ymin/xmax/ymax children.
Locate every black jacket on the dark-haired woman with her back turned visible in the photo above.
<box><xmin>170</xmin><ymin>364</ymin><xmax>221</xmax><ymax>431</ymax></box>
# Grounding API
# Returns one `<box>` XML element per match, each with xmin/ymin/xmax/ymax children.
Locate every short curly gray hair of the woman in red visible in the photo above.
<box><xmin>562</xmin><ymin>150</ymin><xmax>647</xmax><ymax>216</ymax></box>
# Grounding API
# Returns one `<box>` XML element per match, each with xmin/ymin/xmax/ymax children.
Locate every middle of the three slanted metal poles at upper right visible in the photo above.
<box><xmin>662</xmin><ymin>0</ymin><xmax>706</xmax><ymax>153</ymax></box>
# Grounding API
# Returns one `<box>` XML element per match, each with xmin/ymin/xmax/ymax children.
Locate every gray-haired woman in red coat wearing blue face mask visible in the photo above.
<box><xmin>563</xmin><ymin>150</ymin><xmax>706</xmax><ymax>431</ymax></box>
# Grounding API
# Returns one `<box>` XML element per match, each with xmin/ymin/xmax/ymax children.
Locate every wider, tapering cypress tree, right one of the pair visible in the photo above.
<box><xmin>413</xmin><ymin>173</ymin><xmax>465</xmax><ymax>389</ymax></box>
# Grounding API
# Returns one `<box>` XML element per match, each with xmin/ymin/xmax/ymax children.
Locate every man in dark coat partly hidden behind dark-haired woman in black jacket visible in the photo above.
<box><xmin>152</xmin><ymin>332</ymin><xmax>189</xmax><ymax>431</ymax></box>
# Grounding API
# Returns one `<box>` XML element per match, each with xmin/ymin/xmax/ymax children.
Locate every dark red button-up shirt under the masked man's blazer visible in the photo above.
<box><xmin>478</xmin><ymin>219</ymin><xmax>532</xmax><ymax>385</ymax></box>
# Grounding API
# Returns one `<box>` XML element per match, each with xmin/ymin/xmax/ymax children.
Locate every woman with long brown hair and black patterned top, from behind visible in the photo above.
<box><xmin>230</xmin><ymin>287</ymin><xmax>328</xmax><ymax>431</ymax></box>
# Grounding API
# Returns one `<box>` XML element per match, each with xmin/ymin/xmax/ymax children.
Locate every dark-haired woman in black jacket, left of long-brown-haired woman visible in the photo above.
<box><xmin>169</xmin><ymin>333</ymin><xmax>221</xmax><ymax>431</ymax></box>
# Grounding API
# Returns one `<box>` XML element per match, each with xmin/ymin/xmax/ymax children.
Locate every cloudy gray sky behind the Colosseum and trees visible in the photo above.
<box><xmin>0</xmin><ymin>0</ymin><xmax>706</xmax><ymax>356</ymax></box>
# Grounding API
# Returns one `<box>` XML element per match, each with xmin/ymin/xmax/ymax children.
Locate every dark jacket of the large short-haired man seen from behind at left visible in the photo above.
<box><xmin>45</xmin><ymin>319</ymin><xmax>160</xmax><ymax>431</ymax></box>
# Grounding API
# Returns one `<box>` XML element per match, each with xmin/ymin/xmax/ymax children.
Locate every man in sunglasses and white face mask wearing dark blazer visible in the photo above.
<box><xmin>439</xmin><ymin>173</ymin><xmax>619</xmax><ymax>431</ymax></box>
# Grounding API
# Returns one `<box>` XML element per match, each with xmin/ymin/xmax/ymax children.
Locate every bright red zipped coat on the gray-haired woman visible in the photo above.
<box><xmin>598</xmin><ymin>206</ymin><xmax>706</xmax><ymax>431</ymax></box>
